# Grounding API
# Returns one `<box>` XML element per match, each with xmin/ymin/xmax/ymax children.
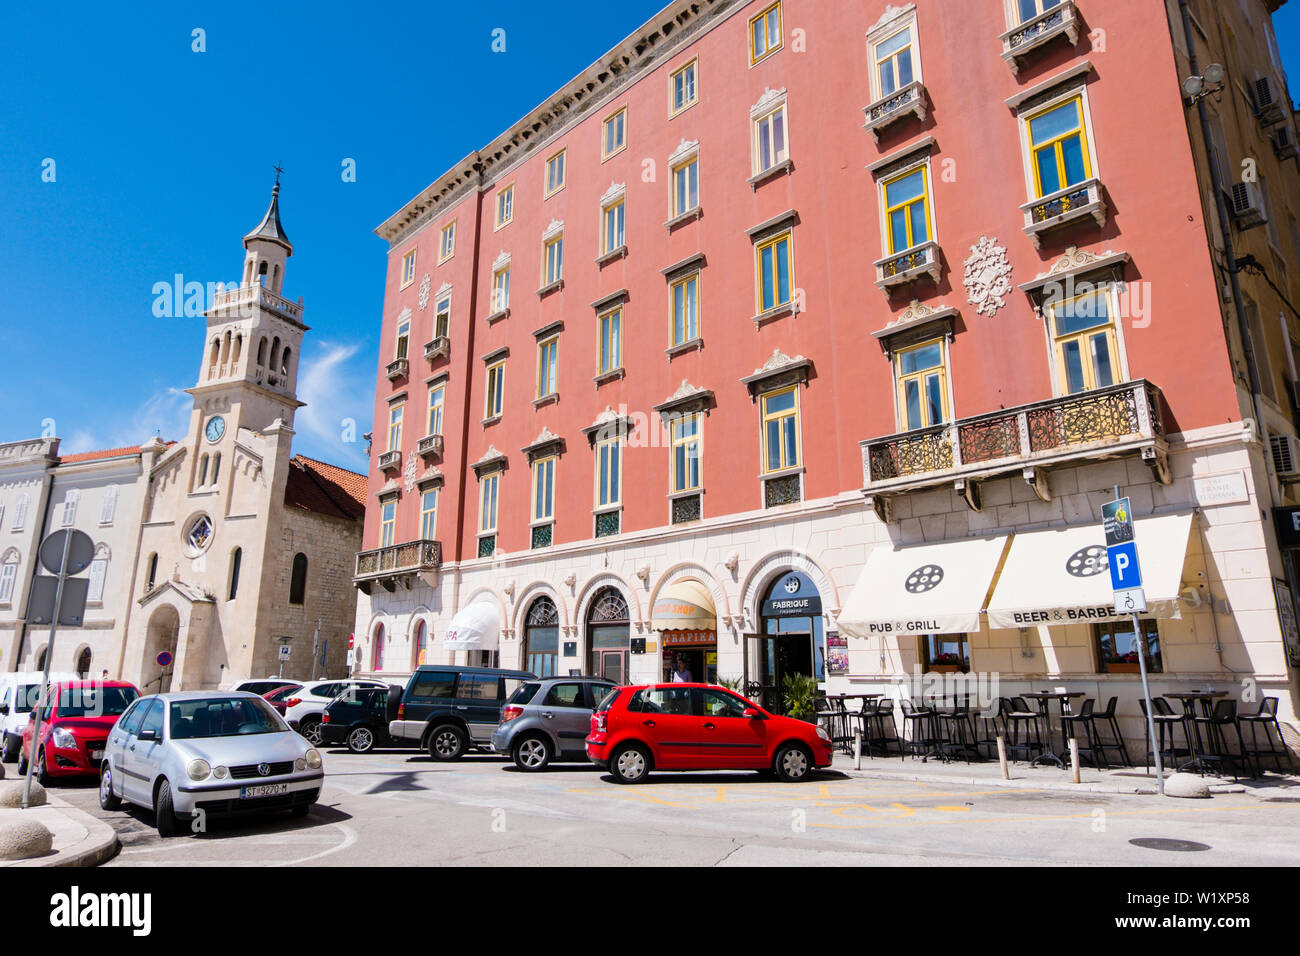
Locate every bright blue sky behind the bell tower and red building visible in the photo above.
<box><xmin>0</xmin><ymin>0</ymin><xmax>1300</xmax><ymax>471</ymax></box>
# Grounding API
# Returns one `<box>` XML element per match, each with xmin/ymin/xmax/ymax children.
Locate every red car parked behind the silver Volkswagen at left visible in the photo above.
<box><xmin>18</xmin><ymin>680</ymin><xmax>140</xmax><ymax>784</ymax></box>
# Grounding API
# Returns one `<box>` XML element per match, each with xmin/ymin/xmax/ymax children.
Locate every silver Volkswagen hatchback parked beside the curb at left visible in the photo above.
<box><xmin>99</xmin><ymin>691</ymin><xmax>325</xmax><ymax>836</ymax></box>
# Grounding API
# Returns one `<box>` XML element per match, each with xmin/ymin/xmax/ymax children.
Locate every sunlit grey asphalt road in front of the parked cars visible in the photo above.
<box><xmin>15</xmin><ymin>750</ymin><xmax>1300</xmax><ymax>866</ymax></box>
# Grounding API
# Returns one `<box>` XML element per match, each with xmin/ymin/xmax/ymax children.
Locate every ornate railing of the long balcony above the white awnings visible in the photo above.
<box><xmin>861</xmin><ymin>380</ymin><xmax>1165</xmax><ymax>494</ymax></box>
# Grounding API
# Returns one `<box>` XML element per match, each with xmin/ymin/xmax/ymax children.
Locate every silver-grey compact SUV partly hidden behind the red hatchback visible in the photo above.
<box><xmin>491</xmin><ymin>678</ymin><xmax>614</xmax><ymax>771</ymax></box>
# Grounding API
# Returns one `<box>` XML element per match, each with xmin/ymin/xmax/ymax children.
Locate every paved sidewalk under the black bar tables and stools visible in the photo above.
<box><xmin>835</xmin><ymin>753</ymin><xmax>1300</xmax><ymax>803</ymax></box>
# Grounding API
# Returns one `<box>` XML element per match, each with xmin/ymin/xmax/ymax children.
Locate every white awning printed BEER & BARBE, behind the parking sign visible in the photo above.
<box><xmin>988</xmin><ymin>512</ymin><xmax>1192</xmax><ymax>627</ymax></box>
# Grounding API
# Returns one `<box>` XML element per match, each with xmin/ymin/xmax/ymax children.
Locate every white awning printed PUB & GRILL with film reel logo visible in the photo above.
<box><xmin>840</xmin><ymin>535</ymin><xmax>1006</xmax><ymax>637</ymax></box>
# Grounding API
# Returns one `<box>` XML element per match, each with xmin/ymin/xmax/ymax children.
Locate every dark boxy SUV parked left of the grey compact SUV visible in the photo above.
<box><xmin>389</xmin><ymin>665</ymin><xmax>536</xmax><ymax>760</ymax></box>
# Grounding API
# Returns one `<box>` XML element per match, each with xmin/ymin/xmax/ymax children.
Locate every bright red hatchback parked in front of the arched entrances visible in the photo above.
<box><xmin>586</xmin><ymin>684</ymin><xmax>832</xmax><ymax>783</ymax></box>
